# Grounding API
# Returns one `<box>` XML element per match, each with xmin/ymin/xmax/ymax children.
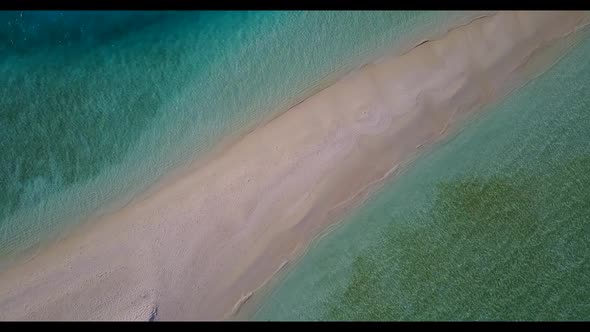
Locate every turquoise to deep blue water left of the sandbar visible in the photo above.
<box><xmin>0</xmin><ymin>11</ymin><xmax>471</xmax><ymax>265</ymax></box>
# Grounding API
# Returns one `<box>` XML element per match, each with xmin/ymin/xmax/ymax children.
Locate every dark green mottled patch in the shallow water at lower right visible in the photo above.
<box><xmin>326</xmin><ymin>157</ymin><xmax>590</xmax><ymax>320</ymax></box>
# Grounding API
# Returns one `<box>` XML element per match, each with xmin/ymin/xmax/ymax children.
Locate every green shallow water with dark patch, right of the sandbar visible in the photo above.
<box><xmin>253</xmin><ymin>29</ymin><xmax>590</xmax><ymax>320</ymax></box>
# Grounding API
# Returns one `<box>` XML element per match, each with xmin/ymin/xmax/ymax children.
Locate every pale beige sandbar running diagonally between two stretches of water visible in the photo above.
<box><xmin>0</xmin><ymin>12</ymin><xmax>589</xmax><ymax>320</ymax></box>
